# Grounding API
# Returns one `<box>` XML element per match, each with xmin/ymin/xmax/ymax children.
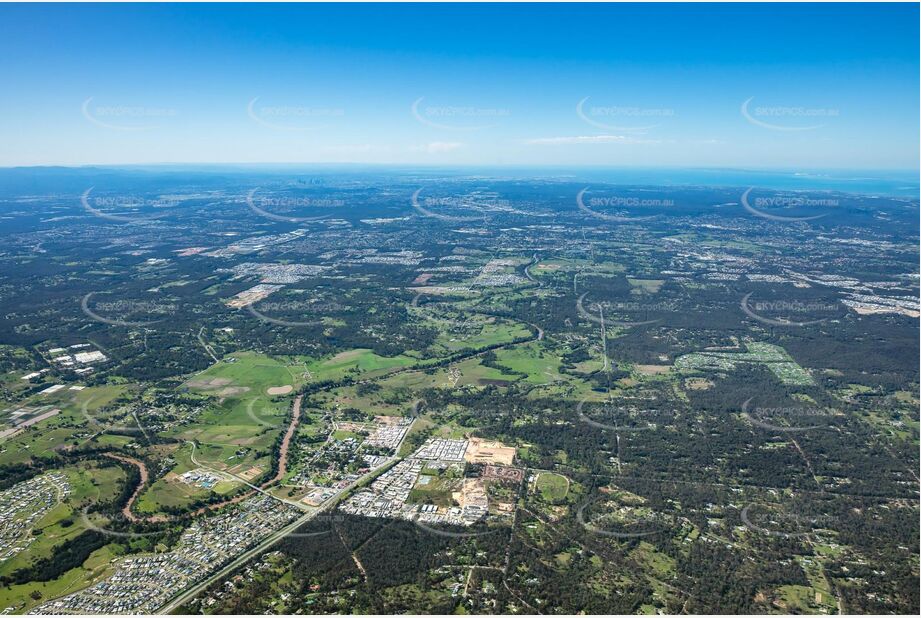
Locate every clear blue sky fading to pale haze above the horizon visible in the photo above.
<box><xmin>0</xmin><ymin>4</ymin><xmax>919</xmax><ymax>170</ymax></box>
